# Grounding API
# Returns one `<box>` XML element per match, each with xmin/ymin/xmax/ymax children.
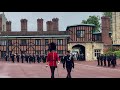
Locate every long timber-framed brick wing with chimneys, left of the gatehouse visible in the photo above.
<box><xmin>0</xmin><ymin>15</ymin><xmax>69</xmax><ymax>57</ymax></box>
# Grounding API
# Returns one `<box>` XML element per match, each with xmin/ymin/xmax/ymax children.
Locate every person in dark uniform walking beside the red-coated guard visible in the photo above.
<box><xmin>63</xmin><ymin>51</ymin><xmax>74</xmax><ymax>78</ymax></box>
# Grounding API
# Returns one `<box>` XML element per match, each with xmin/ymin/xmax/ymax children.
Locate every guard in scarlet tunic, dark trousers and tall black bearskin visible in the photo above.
<box><xmin>46</xmin><ymin>42</ymin><xmax>60</xmax><ymax>78</ymax></box>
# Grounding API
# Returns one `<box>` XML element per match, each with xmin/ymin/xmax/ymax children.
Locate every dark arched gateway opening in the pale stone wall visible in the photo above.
<box><xmin>72</xmin><ymin>44</ymin><xmax>86</xmax><ymax>61</ymax></box>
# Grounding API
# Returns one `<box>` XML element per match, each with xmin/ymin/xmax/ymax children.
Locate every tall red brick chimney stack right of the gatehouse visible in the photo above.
<box><xmin>101</xmin><ymin>16</ymin><xmax>112</xmax><ymax>45</ymax></box>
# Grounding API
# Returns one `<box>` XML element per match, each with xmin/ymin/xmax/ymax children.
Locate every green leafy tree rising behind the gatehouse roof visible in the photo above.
<box><xmin>82</xmin><ymin>15</ymin><xmax>100</xmax><ymax>31</ymax></box>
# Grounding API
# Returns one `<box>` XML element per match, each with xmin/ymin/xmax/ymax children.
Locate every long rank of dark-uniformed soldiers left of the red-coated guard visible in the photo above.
<box><xmin>5</xmin><ymin>53</ymin><xmax>46</xmax><ymax>63</ymax></box>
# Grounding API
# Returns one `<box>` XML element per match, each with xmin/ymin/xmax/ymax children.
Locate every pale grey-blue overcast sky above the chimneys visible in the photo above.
<box><xmin>0</xmin><ymin>12</ymin><xmax>102</xmax><ymax>31</ymax></box>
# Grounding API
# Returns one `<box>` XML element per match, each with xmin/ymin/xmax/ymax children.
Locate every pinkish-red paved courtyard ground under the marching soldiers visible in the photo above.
<box><xmin>0</xmin><ymin>60</ymin><xmax>120</xmax><ymax>78</ymax></box>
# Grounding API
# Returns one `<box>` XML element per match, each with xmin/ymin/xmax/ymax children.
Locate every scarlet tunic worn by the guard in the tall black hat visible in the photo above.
<box><xmin>47</xmin><ymin>52</ymin><xmax>60</xmax><ymax>66</ymax></box>
